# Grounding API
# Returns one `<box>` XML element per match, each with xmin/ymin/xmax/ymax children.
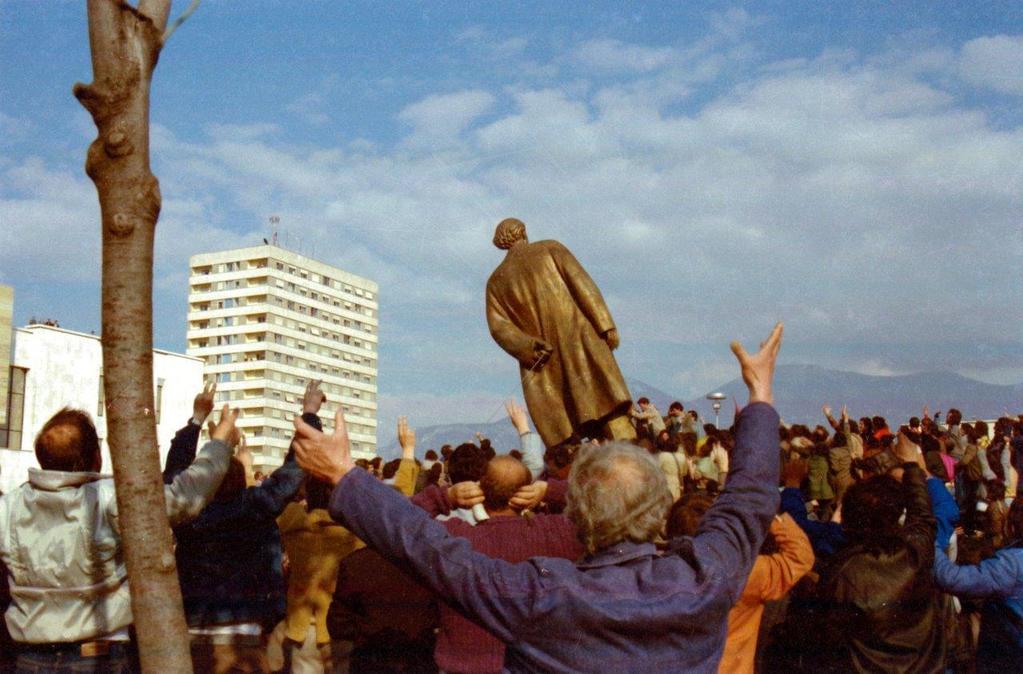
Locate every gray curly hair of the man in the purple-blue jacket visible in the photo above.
<box><xmin>565</xmin><ymin>442</ymin><xmax>671</xmax><ymax>554</ymax></box>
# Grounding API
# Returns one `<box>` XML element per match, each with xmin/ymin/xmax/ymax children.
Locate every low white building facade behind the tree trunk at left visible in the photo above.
<box><xmin>0</xmin><ymin>325</ymin><xmax>203</xmax><ymax>492</ymax></box>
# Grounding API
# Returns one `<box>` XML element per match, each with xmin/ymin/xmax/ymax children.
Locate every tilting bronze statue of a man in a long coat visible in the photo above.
<box><xmin>487</xmin><ymin>218</ymin><xmax>635</xmax><ymax>447</ymax></box>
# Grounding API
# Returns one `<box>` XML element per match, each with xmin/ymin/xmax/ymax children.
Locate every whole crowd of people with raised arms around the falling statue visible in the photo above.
<box><xmin>0</xmin><ymin>326</ymin><xmax>1023</xmax><ymax>672</ymax></box>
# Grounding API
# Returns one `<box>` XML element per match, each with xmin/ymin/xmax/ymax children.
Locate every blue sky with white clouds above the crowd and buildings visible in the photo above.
<box><xmin>0</xmin><ymin>0</ymin><xmax>1023</xmax><ymax>443</ymax></box>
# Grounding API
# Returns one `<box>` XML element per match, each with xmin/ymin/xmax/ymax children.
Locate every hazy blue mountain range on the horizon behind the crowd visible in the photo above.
<box><xmin>381</xmin><ymin>365</ymin><xmax>1023</xmax><ymax>456</ymax></box>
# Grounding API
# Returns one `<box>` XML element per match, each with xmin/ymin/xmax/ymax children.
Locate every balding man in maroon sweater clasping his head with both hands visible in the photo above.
<box><xmin>434</xmin><ymin>455</ymin><xmax>583</xmax><ymax>672</ymax></box>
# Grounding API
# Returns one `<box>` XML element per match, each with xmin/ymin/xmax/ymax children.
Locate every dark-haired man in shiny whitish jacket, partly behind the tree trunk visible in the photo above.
<box><xmin>0</xmin><ymin>393</ymin><xmax>239</xmax><ymax>671</ymax></box>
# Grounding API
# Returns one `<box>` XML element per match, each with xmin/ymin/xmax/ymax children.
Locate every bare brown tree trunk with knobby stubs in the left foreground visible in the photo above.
<box><xmin>74</xmin><ymin>0</ymin><xmax>191</xmax><ymax>674</ymax></box>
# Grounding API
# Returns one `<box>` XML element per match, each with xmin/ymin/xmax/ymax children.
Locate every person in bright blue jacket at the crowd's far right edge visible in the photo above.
<box><xmin>934</xmin><ymin>498</ymin><xmax>1023</xmax><ymax>672</ymax></box>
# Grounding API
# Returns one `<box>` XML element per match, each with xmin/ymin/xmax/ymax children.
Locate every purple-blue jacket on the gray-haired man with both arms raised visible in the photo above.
<box><xmin>330</xmin><ymin>403</ymin><xmax>779</xmax><ymax>672</ymax></box>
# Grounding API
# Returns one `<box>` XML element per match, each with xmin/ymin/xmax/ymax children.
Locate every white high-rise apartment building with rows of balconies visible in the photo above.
<box><xmin>187</xmin><ymin>245</ymin><xmax>379</xmax><ymax>471</ymax></box>
